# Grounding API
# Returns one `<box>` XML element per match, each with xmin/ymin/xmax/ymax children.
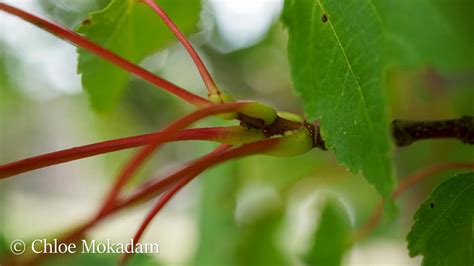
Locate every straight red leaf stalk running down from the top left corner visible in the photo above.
<box><xmin>0</xmin><ymin>3</ymin><xmax>210</xmax><ymax>108</ymax></box>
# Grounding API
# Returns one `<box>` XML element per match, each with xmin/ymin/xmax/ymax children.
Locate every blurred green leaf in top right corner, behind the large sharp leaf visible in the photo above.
<box><xmin>374</xmin><ymin>0</ymin><xmax>474</xmax><ymax>70</ymax></box>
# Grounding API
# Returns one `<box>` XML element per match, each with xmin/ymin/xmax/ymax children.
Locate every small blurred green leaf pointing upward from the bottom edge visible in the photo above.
<box><xmin>304</xmin><ymin>199</ymin><xmax>351</xmax><ymax>266</ymax></box>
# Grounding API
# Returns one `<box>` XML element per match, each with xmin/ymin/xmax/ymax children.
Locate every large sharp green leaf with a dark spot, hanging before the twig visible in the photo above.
<box><xmin>283</xmin><ymin>0</ymin><xmax>394</xmax><ymax>196</ymax></box>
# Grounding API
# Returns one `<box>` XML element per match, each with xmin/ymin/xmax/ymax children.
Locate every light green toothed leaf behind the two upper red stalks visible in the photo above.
<box><xmin>77</xmin><ymin>0</ymin><xmax>200</xmax><ymax>111</ymax></box>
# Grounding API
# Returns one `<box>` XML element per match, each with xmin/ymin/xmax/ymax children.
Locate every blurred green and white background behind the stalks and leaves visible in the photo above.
<box><xmin>0</xmin><ymin>0</ymin><xmax>474</xmax><ymax>266</ymax></box>
